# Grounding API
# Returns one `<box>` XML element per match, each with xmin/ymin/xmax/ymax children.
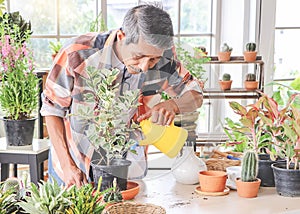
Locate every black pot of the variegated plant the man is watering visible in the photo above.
<box><xmin>91</xmin><ymin>159</ymin><xmax>131</xmax><ymax>191</ymax></box>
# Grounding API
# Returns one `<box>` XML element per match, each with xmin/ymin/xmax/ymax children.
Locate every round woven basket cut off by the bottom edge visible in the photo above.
<box><xmin>102</xmin><ymin>202</ymin><xmax>166</xmax><ymax>214</ymax></box>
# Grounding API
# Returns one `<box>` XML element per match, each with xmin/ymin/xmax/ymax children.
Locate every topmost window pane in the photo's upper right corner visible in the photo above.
<box><xmin>276</xmin><ymin>0</ymin><xmax>300</xmax><ymax>27</ymax></box>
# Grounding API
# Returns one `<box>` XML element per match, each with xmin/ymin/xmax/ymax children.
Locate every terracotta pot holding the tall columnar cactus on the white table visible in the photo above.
<box><xmin>235</xmin><ymin>178</ymin><xmax>261</xmax><ymax>198</ymax></box>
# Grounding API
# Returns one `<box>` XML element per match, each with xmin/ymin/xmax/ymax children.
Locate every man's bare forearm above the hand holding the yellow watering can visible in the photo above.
<box><xmin>172</xmin><ymin>91</ymin><xmax>203</xmax><ymax>114</ymax></box>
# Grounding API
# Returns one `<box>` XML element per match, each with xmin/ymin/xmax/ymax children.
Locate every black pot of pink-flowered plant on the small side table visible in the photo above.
<box><xmin>2</xmin><ymin>118</ymin><xmax>36</xmax><ymax>146</ymax></box>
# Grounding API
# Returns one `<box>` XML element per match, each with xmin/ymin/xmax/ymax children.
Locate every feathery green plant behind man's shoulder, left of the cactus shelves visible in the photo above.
<box><xmin>176</xmin><ymin>44</ymin><xmax>211</xmax><ymax>80</ymax></box>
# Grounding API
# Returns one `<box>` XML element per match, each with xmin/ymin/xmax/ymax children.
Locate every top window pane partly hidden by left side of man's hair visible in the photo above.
<box><xmin>107</xmin><ymin>0</ymin><xmax>137</xmax><ymax>29</ymax></box>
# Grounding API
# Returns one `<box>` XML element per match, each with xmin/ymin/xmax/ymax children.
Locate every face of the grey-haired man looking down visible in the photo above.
<box><xmin>120</xmin><ymin>33</ymin><xmax>164</xmax><ymax>74</ymax></box>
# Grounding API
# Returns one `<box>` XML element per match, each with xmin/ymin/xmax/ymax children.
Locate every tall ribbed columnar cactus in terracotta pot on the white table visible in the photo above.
<box><xmin>235</xmin><ymin>150</ymin><xmax>261</xmax><ymax>198</ymax></box>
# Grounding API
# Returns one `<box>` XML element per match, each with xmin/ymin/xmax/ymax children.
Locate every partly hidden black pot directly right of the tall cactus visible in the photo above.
<box><xmin>257</xmin><ymin>154</ymin><xmax>285</xmax><ymax>187</ymax></box>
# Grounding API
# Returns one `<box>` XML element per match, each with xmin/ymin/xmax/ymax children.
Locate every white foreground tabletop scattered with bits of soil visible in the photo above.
<box><xmin>134</xmin><ymin>171</ymin><xmax>300</xmax><ymax>214</ymax></box>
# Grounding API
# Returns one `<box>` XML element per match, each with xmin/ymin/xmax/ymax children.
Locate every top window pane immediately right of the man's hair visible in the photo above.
<box><xmin>180</xmin><ymin>0</ymin><xmax>211</xmax><ymax>34</ymax></box>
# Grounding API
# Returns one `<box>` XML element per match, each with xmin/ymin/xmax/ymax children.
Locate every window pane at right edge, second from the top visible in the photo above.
<box><xmin>274</xmin><ymin>29</ymin><xmax>300</xmax><ymax>79</ymax></box>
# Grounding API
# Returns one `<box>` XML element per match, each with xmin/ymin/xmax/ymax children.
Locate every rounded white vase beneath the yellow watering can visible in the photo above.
<box><xmin>171</xmin><ymin>146</ymin><xmax>207</xmax><ymax>184</ymax></box>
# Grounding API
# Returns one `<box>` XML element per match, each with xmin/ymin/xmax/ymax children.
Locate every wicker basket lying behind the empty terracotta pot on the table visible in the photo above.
<box><xmin>205</xmin><ymin>151</ymin><xmax>243</xmax><ymax>171</ymax></box>
